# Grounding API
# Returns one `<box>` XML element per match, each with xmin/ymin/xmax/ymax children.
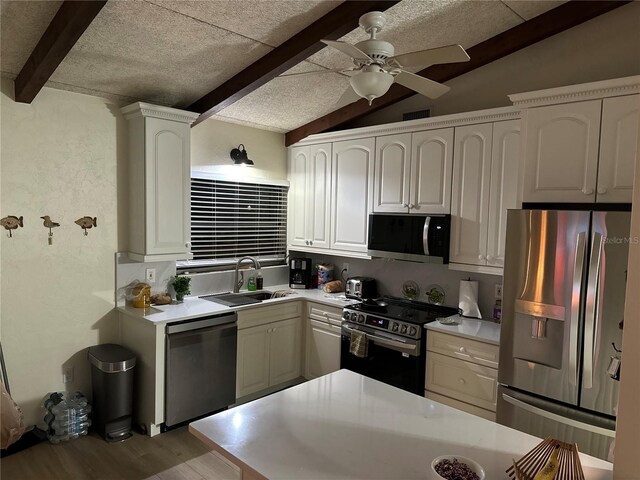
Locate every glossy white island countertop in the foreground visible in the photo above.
<box><xmin>189</xmin><ymin>370</ymin><xmax>613</xmax><ymax>480</ymax></box>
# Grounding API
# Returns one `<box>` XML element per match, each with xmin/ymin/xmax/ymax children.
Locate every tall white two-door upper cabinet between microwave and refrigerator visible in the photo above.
<box><xmin>450</xmin><ymin>120</ymin><xmax>520</xmax><ymax>274</ymax></box>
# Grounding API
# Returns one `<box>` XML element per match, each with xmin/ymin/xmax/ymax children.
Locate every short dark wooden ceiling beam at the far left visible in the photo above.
<box><xmin>14</xmin><ymin>0</ymin><xmax>107</xmax><ymax>103</ymax></box>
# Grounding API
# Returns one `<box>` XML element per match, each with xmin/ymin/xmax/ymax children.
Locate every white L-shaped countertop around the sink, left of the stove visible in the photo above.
<box><xmin>118</xmin><ymin>285</ymin><xmax>353</xmax><ymax>324</ymax></box>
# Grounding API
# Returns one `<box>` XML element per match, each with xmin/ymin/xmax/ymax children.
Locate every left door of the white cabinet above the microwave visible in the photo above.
<box><xmin>373</xmin><ymin>133</ymin><xmax>411</xmax><ymax>213</ymax></box>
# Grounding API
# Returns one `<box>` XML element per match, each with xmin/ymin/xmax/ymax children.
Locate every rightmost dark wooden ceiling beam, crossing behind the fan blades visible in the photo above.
<box><xmin>285</xmin><ymin>0</ymin><xmax>630</xmax><ymax>146</ymax></box>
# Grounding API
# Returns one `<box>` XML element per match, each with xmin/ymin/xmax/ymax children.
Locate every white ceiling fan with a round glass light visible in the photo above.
<box><xmin>282</xmin><ymin>12</ymin><xmax>469</xmax><ymax>105</ymax></box>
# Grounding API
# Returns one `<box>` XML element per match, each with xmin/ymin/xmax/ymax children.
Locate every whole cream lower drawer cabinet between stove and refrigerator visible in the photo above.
<box><xmin>425</xmin><ymin>331</ymin><xmax>498</xmax><ymax>421</ymax></box>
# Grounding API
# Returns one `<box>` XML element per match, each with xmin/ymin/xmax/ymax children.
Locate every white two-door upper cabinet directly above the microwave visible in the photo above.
<box><xmin>373</xmin><ymin>128</ymin><xmax>453</xmax><ymax>214</ymax></box>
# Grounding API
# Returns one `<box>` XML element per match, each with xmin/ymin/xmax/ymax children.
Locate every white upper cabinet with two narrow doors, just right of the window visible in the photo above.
<box><xmin>289</xmin><ymin>143</ymin><xmax>331</xmax><ymax>248</ymax></box>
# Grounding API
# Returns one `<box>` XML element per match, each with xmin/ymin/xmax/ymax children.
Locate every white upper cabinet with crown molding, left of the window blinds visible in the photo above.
<box><xmin>122</xmin><ymin>103</ymin><xmax>199</xmax><ymax>262</ymax></box>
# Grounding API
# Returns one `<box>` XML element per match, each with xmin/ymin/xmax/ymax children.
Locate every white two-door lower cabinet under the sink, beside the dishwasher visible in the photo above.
<box><xmin>236</xmin><ymin>302</ymin><xmax>302</xmax><ymax>398</ymax></box>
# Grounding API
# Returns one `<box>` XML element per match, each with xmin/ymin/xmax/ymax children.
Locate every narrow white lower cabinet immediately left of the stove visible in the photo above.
<box><xmin>304</xmin><ymin>302</ymin><xmax>342</xmax><ymax>380</ymax></box>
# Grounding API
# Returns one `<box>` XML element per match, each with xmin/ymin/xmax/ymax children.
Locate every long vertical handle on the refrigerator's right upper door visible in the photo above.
<box><xmin>582</xmin><ymin>232</ymin><xmax>602</xmax><ymax>388</ymax></box>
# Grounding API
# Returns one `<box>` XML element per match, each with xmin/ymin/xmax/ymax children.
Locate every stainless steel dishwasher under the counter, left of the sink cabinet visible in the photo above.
<box><xmin>165</xmin><ymin>312</ymin><xmax>238</xmax><ymax>427</ymax></box>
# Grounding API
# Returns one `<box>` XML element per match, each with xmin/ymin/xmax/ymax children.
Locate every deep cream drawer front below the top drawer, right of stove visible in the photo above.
<box><xmin>426</xmin><ymin>352</ymin><xmax>498</xmax><ymax>412</ymax></box>
